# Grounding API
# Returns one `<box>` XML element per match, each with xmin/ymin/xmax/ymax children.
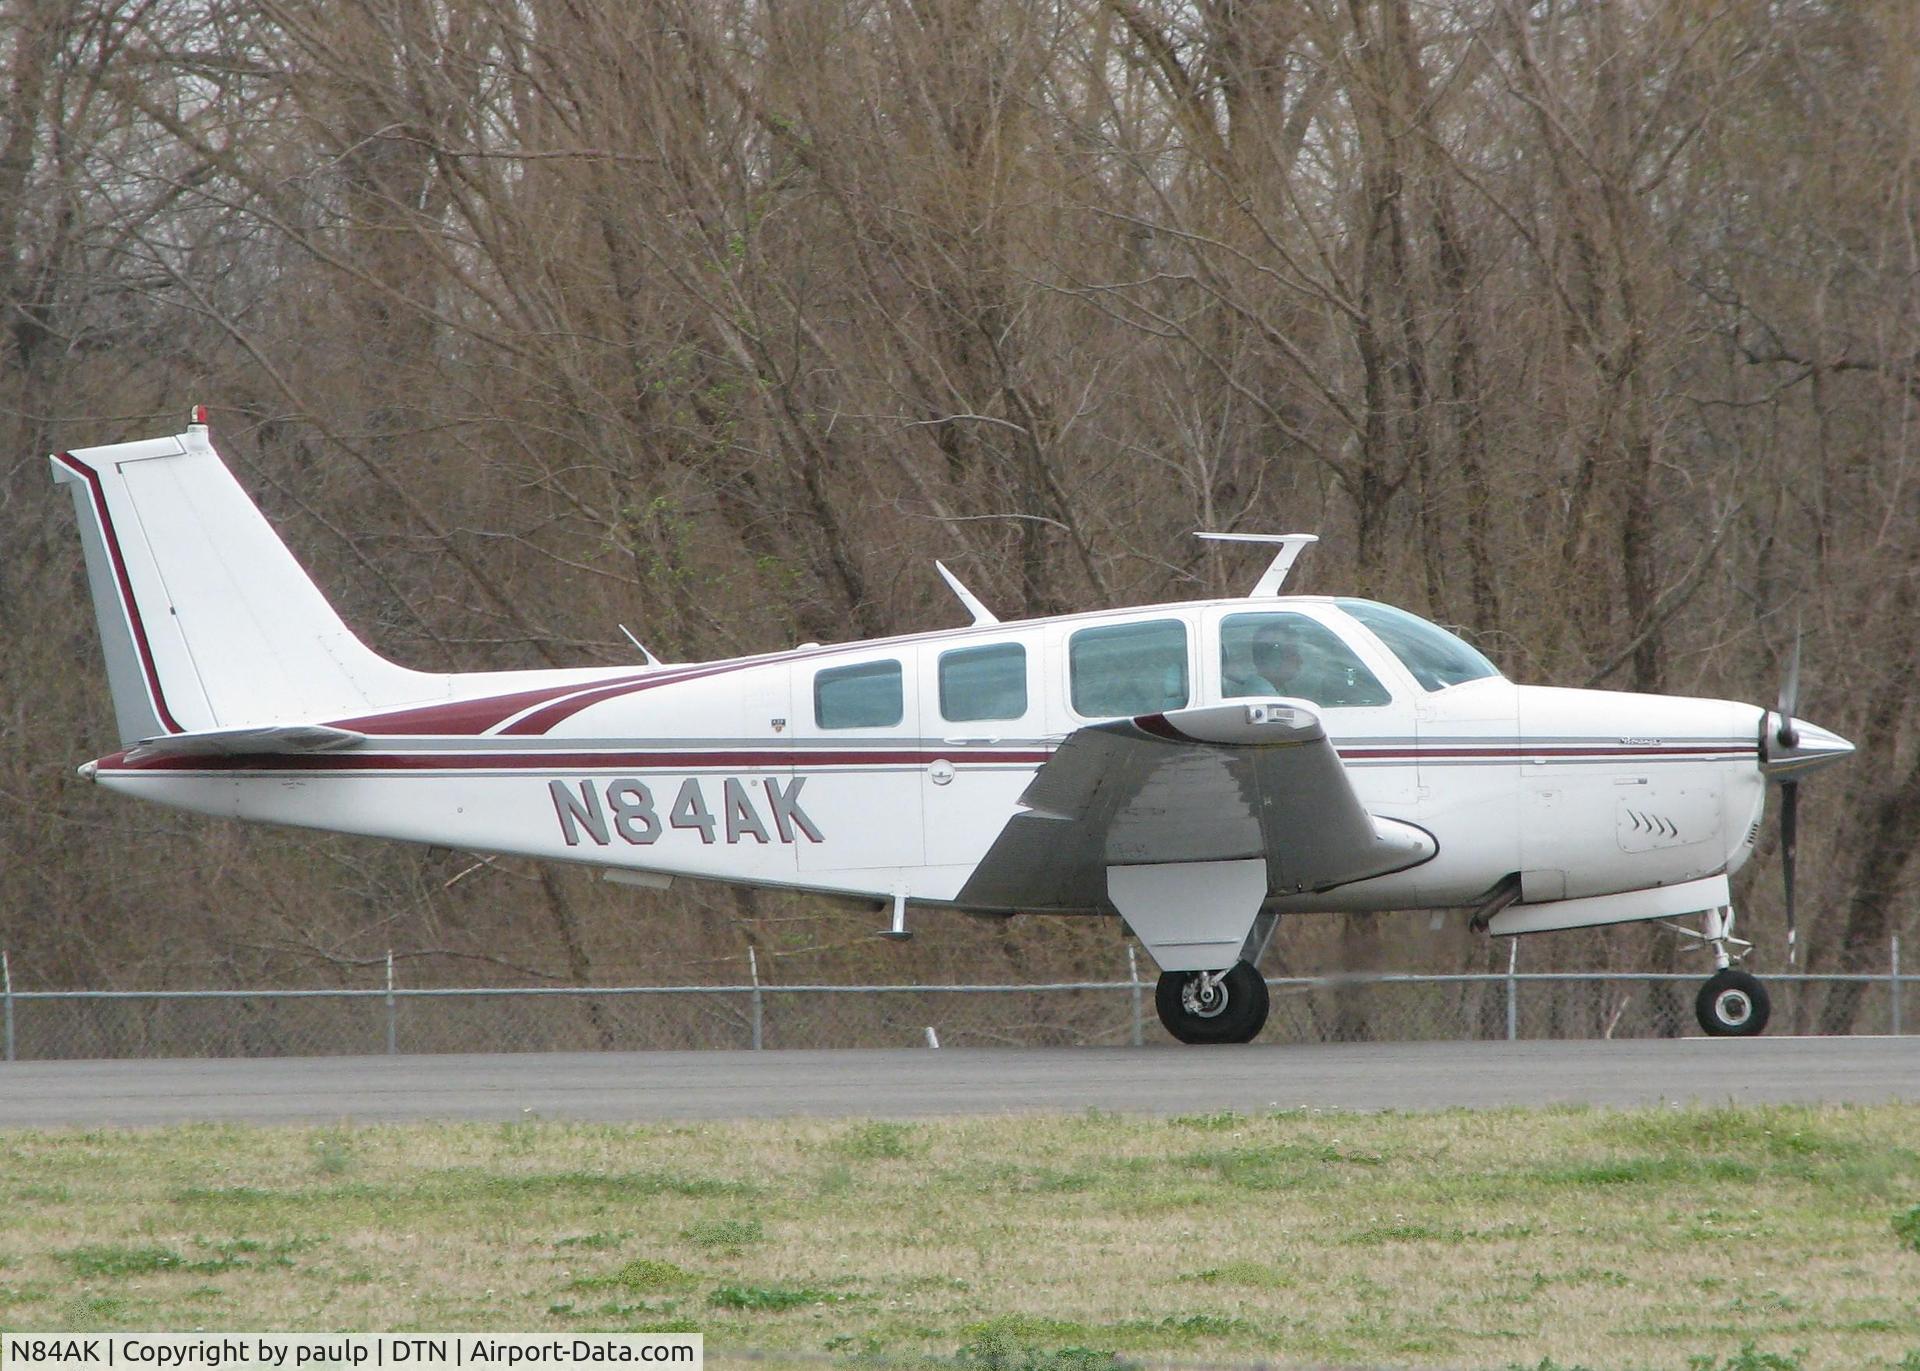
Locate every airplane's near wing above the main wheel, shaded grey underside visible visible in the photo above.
<box><xmin>956</xmin><ymin>699</ymin><xmax>1434</xmax><ymax>910</ymax></box>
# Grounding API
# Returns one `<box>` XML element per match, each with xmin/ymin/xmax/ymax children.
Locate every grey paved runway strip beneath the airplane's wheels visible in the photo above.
<box><xmin>0</xmin><ymin>1037</ymin><xmax>1920</xmax><ymax>1127</ymax></box>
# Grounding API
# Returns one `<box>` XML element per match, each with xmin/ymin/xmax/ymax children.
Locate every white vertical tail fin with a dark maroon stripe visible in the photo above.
<box><xmin>52</xmin><ymin>410</ymin><xmax>447</xmax><ymax>745</ymax></box>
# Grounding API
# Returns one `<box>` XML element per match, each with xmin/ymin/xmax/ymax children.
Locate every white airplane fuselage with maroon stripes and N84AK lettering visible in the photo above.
<box><xmin>94</xmin><ymin>597</ymin><xmax>1764</xmax><ymax>912</ymax></box>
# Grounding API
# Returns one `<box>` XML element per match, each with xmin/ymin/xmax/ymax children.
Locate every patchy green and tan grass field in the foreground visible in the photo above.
<box><xmin>0</xmin><ymin>1106</ymin><xmax>1920</xmax><ymax>1371</ymax></box>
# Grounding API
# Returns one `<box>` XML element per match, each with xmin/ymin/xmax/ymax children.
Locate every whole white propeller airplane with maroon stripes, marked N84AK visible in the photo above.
<box><xmin>52</xmin><ymin>409</ymin><xmax>1853</xmax><ymax>1043</ymax></box>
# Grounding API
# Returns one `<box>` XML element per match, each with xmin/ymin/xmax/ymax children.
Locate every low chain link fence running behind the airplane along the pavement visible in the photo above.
<box><xmin>0</xmin><ymin>943</ymin><xmax>1920</xmax><ymax>1062</ymax></box>
